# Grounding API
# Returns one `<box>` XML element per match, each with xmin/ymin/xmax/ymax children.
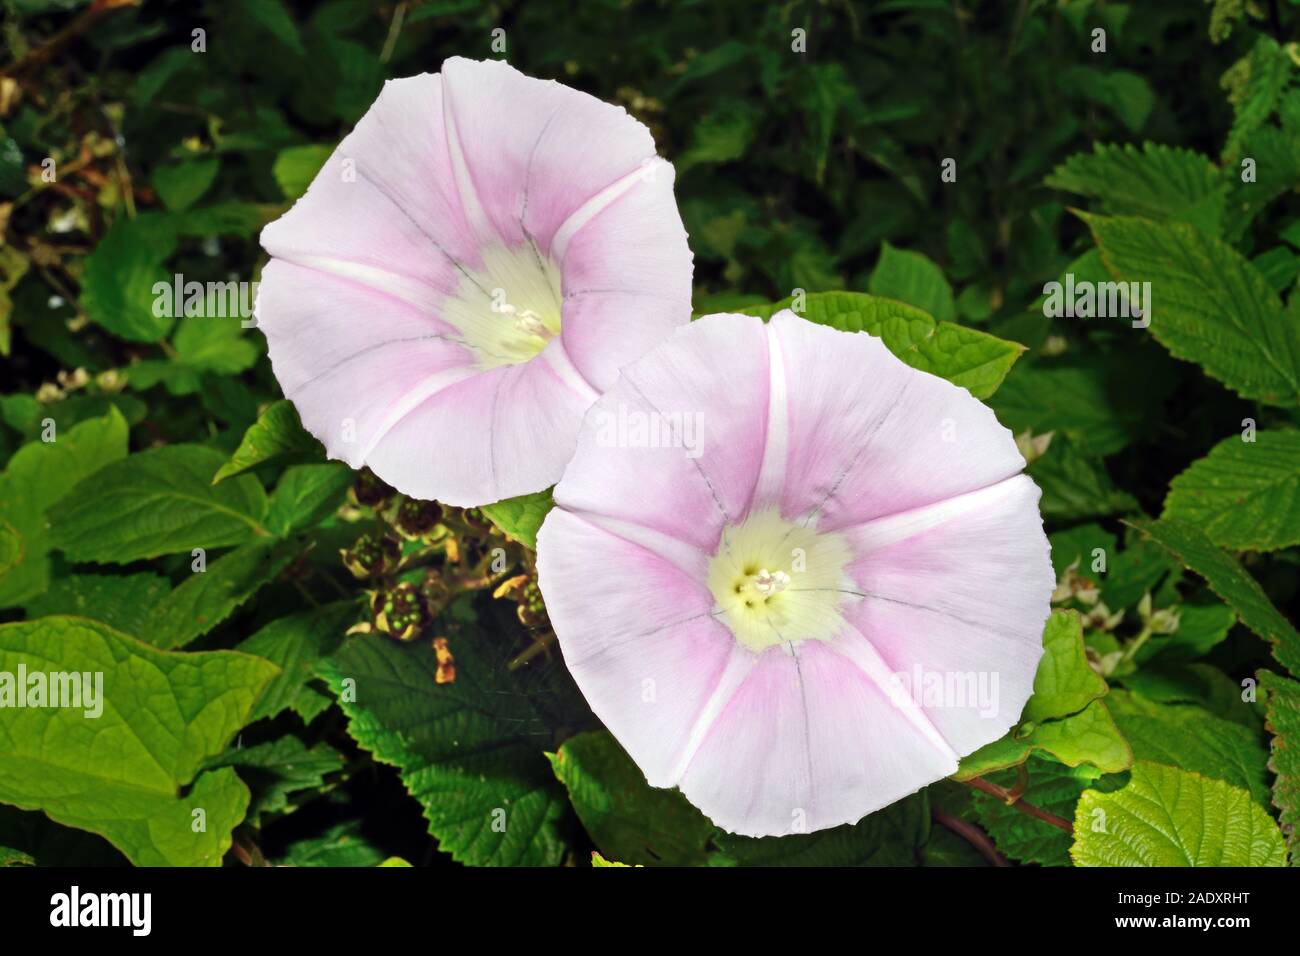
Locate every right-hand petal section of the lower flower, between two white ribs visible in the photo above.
<box><xmin>845</xmin><ymin>475</ymin><xmax>1056</xmax><ymax>753</ymax></box>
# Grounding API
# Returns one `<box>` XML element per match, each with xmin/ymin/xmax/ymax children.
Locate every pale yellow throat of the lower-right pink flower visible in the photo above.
<box><xmin>709</xmin><ymin>509</ymin><xmax>852</xmax><ymax>650</ymax></box>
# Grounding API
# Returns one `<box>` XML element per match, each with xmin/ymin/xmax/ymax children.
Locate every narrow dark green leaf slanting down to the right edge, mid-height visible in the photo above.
<box><xmin>1126</xmin><ymin>518</ymin><xmax>1300</xmax><ymax>674</ymax></box>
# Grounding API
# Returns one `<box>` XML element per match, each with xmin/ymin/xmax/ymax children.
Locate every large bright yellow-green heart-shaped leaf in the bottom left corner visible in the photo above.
<box><xmin>0</xmin><ymin>617</ymin><xmax>276</xmax><ymax>866</ymax></box>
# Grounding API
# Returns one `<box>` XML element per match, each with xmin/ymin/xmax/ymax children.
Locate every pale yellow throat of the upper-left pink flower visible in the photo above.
<box><xmin>443</xmin><ymin>243</ymin><xmax>562</xmax><ymax>369</ymax></box>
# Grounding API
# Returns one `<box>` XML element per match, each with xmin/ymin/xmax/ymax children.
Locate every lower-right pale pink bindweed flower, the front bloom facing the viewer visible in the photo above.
<box><xmin>537</xmin><ymin>311</ymin><xmax>1054</xmax><ymax>836</ymax></box>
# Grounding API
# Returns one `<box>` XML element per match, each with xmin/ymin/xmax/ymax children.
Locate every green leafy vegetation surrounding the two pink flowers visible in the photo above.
<box><xmin>0</xmin><ymin>0</ymin><xmax>1300</xmax><ymax>865</ymax></box>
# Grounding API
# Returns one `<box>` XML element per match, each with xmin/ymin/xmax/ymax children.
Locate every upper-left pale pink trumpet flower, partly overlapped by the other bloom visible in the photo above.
<box><xmin>256</xmin><ymin>57</ymin><xmax>692</xmax><ymax>506</ymax></box>
